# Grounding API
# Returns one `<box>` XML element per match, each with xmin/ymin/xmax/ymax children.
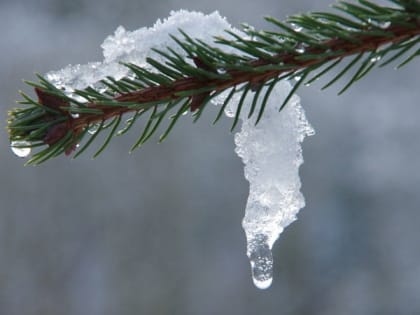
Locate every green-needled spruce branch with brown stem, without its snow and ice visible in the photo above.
<box><xmin>8</xmin><ymin>0</ymin><xmax>420</xmax><ymax>164</ymax></box>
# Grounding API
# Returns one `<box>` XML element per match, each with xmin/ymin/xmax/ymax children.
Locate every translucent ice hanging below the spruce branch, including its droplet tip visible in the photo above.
<box><xmin>226</xmin><ymin>81</ymin><xmax>314</xmax><ymax>289</ymax></box>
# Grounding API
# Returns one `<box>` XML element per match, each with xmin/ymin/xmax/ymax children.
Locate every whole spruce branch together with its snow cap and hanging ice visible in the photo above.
<box><xmin>8</xmin><ymin>0</ymin><xmax>420</xmax><ymax>288</ymax></box>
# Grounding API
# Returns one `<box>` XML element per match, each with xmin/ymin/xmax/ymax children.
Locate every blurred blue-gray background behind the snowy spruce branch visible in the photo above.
<box><xmin>0</xmin><ymin>0</ymin><xmax>420</xmax><ymax>315</ymax></box>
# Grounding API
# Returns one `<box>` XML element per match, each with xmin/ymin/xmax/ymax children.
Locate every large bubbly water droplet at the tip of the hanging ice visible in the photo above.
<box><xmin>247</xmin><ymin>234</ymin><xmax>273</xmax><ymax>289</ymax></box>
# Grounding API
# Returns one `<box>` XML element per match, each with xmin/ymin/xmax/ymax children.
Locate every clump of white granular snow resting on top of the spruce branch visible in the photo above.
<box><xmin>46</xmin><ymin>10</ymin><xmax>235</xmax><ymax>91</ymax></box>
